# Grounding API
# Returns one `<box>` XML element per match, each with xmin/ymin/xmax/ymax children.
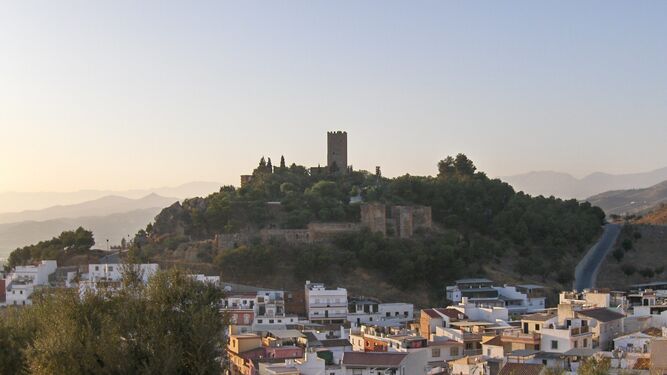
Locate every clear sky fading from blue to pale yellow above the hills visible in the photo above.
<box><xmin>0</xmin><ymin>0</ymin><xmax>667</xmax><ymax>191</ymax></box>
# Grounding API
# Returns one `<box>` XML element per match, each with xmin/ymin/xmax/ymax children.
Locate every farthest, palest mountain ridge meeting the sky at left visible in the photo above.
<box><xmin>0</xmin><ymin>181</ymin><xmax>220</xmax><ymax>214</ymax></box>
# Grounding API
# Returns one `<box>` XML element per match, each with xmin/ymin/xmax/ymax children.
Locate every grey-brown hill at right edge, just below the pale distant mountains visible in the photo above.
<box><xmin>587</xmin><ymin>181</ymin><xmax>667</xmax><ymax>215</ymax></box>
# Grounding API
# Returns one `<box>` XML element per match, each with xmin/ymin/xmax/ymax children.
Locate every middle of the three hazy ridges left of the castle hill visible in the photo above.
<box><xmin>0</xmin><ymin>193</ymin><xmax>178</xmax><ymax>224</ymax></box>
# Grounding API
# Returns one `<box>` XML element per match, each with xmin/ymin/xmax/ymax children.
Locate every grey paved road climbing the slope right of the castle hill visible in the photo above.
<box><xmin>573</xmin><ymin>224</ymin><xmax>621</xmax><ymax>291</ymax></box>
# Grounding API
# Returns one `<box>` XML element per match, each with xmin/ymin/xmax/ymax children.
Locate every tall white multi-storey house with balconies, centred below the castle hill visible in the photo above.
<box><xmin>305</xmin><ymin>281</ymin><xmax>348</xmax><ymax>322</ymax></box>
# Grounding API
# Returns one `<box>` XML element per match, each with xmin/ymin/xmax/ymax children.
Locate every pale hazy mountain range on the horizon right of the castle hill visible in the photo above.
<box><xmin>500</xmin><ymin>167</ymin><xmax>667</xmax><ymax>199</ymax></box>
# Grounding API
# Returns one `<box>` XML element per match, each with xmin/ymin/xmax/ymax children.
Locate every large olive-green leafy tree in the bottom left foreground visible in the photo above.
<box><xmin>0</xmin><ymin>270</ymin><xmax>224</xmax><ymax>375</ymax></box>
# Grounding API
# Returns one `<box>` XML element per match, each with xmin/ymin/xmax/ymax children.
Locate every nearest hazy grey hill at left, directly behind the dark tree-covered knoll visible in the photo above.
<box><xmin>0</xmin><ymin>207</ymin><xmax>161</xmax><ymax>258</ymax></box>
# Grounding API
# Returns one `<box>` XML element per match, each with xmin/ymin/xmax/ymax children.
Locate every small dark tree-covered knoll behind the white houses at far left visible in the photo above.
<box><xmin>6</xmin><ymin>227</ymin><xmax>95</xmax><ymax>269</ymax></box>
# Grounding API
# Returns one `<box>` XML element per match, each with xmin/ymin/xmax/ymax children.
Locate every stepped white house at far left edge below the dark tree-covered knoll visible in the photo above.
<box><xmin>5</xmin><ymin>260</ymin><xmax>58</xmax><ymax>306</ymax></box>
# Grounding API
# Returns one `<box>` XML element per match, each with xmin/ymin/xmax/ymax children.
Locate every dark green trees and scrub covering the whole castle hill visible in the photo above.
<box><xmin>124</xmin><ymin>154</ymin><xmax>605</xmax><ymax>306</ymax></box>
